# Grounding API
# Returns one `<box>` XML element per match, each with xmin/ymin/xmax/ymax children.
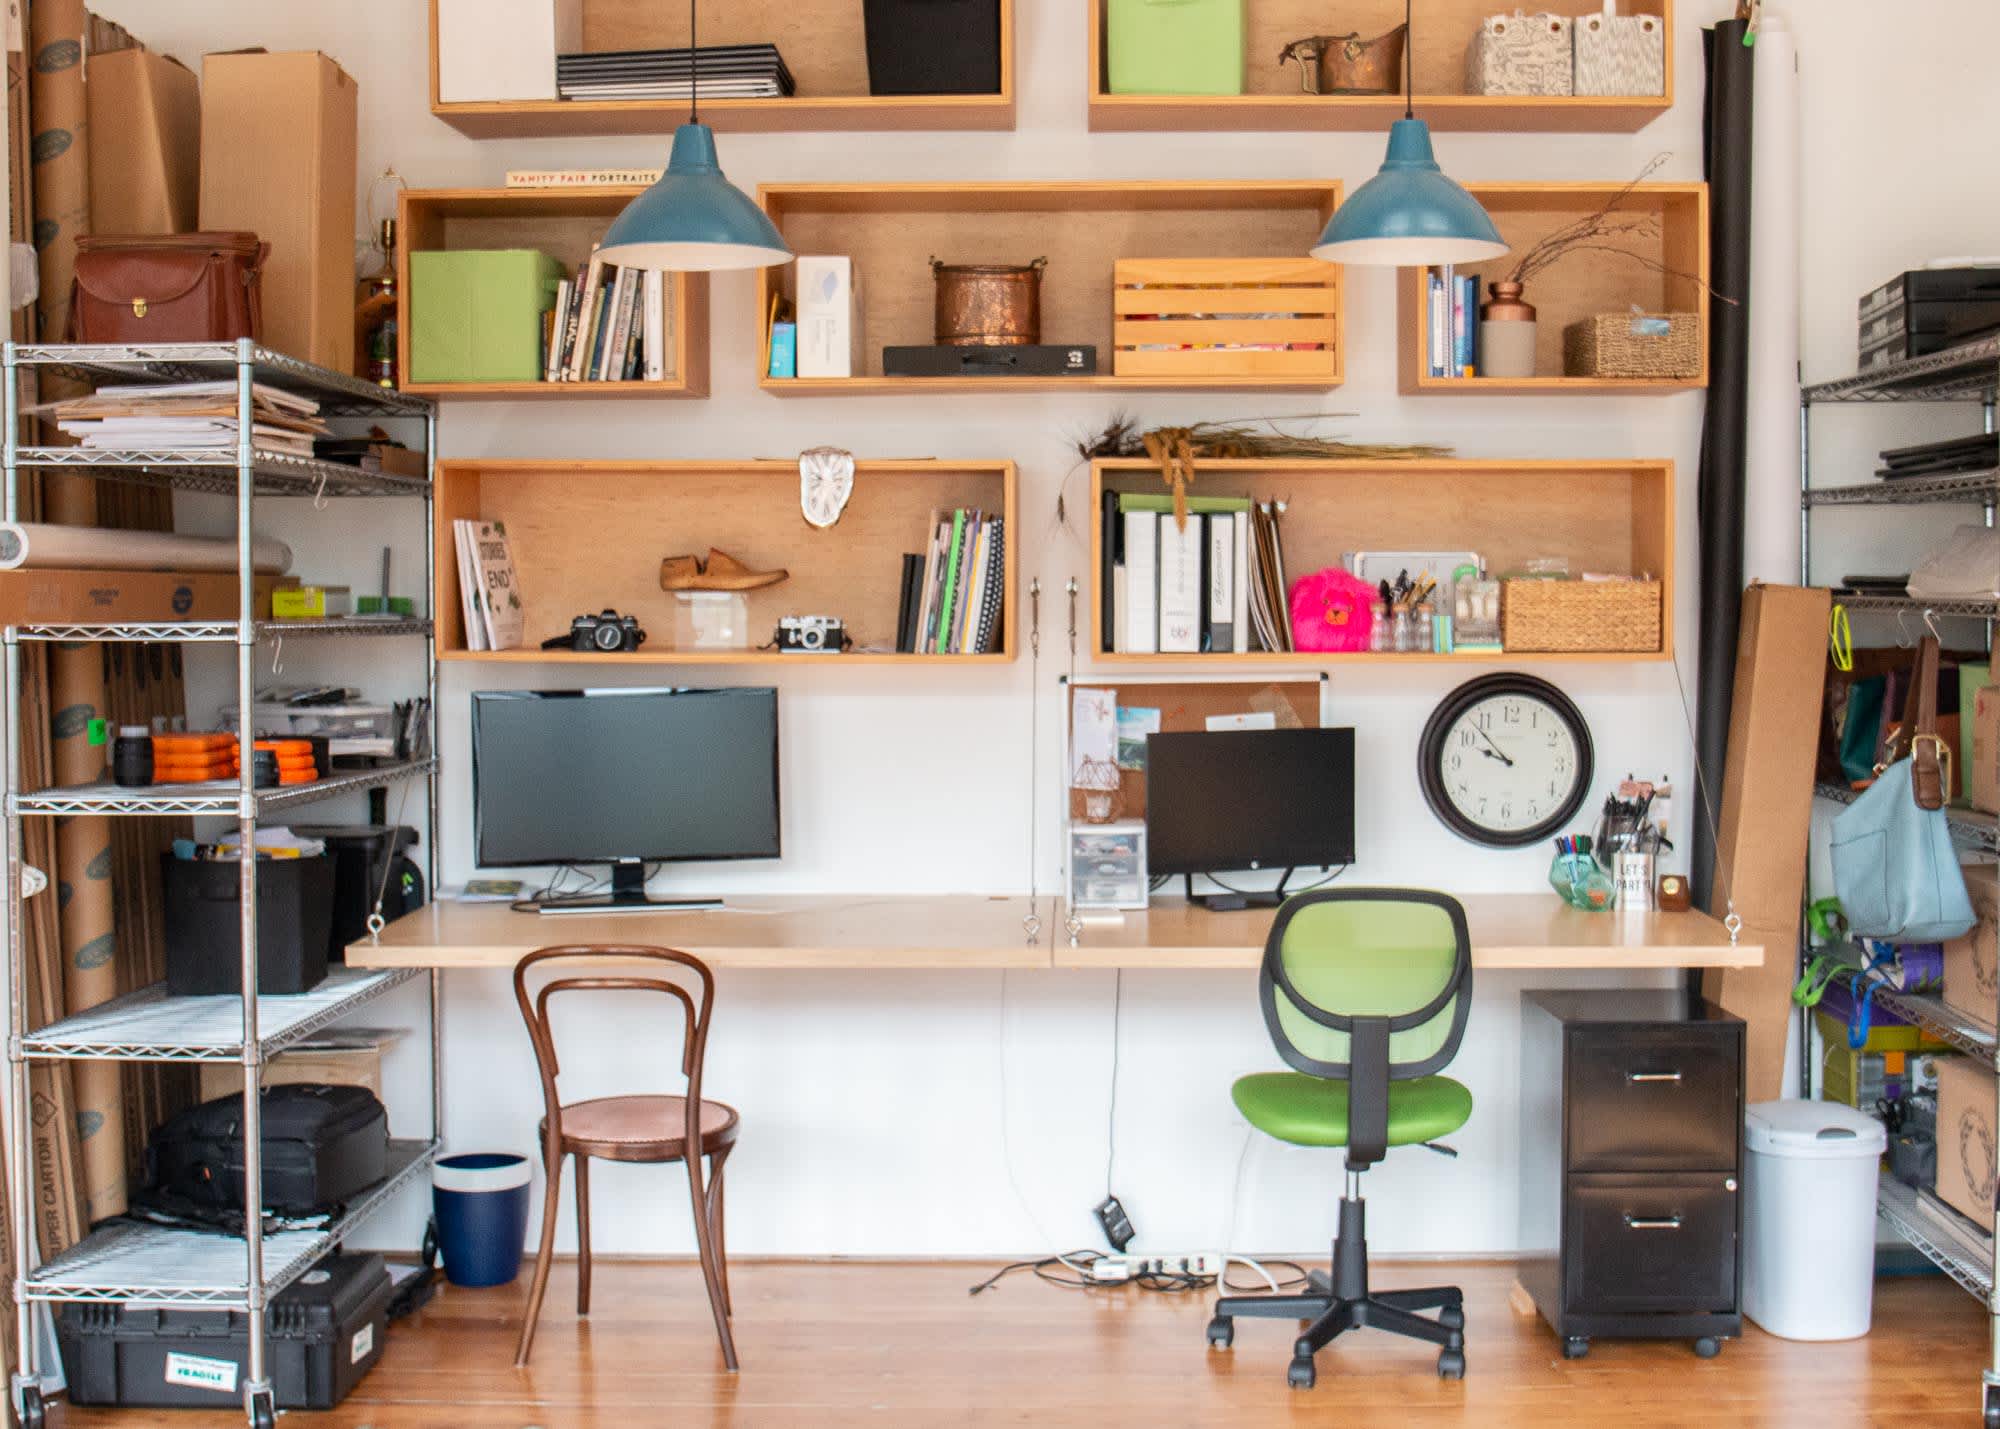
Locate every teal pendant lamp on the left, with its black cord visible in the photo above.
<box><xmin>598</xmin><ymin>0</ymin><xmax>792</xmax><ymax>272</ymax></box>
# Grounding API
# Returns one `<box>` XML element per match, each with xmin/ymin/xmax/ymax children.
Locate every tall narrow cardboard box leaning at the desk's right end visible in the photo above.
<box><xmin>1702</xmin><ymin>584</ymin><xmax>1830</xmax><ymax>1101</ymax></box>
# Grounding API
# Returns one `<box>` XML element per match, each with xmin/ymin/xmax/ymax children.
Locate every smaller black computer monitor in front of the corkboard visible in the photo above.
<box><xmin>1146</xmin><ymin>729</ymin><xmax>1354</xmax><ymax>907</ymax></box>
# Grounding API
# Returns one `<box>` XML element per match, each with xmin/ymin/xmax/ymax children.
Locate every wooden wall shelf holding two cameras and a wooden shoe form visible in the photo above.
<box><xmin>430</xmin><ymin>460</ymin><xmax>1018</xmax><ymax>666</ymax></box>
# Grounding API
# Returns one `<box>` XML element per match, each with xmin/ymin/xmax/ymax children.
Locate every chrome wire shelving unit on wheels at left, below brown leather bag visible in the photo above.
<box><xmin>0</xmin><ymin>340</ymin><xmax>442</xmax><ymax>1429</ymax></box>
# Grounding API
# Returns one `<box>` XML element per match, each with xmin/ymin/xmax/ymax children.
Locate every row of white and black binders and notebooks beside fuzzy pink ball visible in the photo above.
<box><xmin>1098</xmin><ymin>490</ymin><xmax>1292</xmax><ymax>654</ymax></box>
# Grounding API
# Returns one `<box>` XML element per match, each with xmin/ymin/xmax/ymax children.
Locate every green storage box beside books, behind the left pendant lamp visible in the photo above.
<box><xmin>408</xmin><ymin>248</ymin><xmax>568</xmax><ymax>382</ymax></box>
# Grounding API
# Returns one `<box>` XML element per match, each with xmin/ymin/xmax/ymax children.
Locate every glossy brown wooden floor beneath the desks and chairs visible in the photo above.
<box><xmin>50</xmin><ymin>1261</ymin><xmax>1986</xmax><ymax>1429</ymax></box>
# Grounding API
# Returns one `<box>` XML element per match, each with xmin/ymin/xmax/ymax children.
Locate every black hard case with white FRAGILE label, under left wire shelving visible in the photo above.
<box><xmin>56</xmin><ymin>1255</ymin><xmax>394</xmax><ymax>1409</ymax></box>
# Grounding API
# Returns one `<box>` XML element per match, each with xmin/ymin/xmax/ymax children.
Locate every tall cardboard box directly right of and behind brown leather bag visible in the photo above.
<box><xmin>200</xmin><ymin>50</ymin><xmax>358</xmax><ymax>372</ymax></box>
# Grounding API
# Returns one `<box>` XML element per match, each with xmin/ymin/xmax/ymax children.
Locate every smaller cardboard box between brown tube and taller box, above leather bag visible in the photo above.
<box><xmin>84</xmin><ymin>50</ymin><xmax>202</xmax><ymax>234</ymax></box>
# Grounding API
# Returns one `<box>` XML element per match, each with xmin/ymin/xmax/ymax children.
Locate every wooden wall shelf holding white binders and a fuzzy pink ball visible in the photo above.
<box><xmin>1090</xmin><ymin>458</ymin><xmax>1674</xmax><ymax>670</ymax></box>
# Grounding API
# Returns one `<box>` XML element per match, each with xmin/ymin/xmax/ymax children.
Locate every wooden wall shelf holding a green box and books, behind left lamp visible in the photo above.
<box><xmin>396</xmin><ymin>188</ymin><xmax>708</xmax><ymax>400</ymax></box>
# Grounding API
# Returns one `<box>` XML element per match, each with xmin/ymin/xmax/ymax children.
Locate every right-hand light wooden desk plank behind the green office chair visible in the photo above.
<box><xmin>1054</xmin><ymin>893</ymin><xmax>1764</xmax><ymax>969</ymax></box>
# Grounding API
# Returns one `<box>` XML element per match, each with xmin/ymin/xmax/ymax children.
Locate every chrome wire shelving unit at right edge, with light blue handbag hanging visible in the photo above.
<box><xmin>1798</xmin><ymin>338</ymin><xmax>2000</xmax><ymax>1429</ymax></box>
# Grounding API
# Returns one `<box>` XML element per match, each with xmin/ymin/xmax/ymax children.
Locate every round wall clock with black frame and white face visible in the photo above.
<box><xmin>1416</xmin><ymin>674</ymin><xmax>1594</xmax><ymax>849</ymax></box>
